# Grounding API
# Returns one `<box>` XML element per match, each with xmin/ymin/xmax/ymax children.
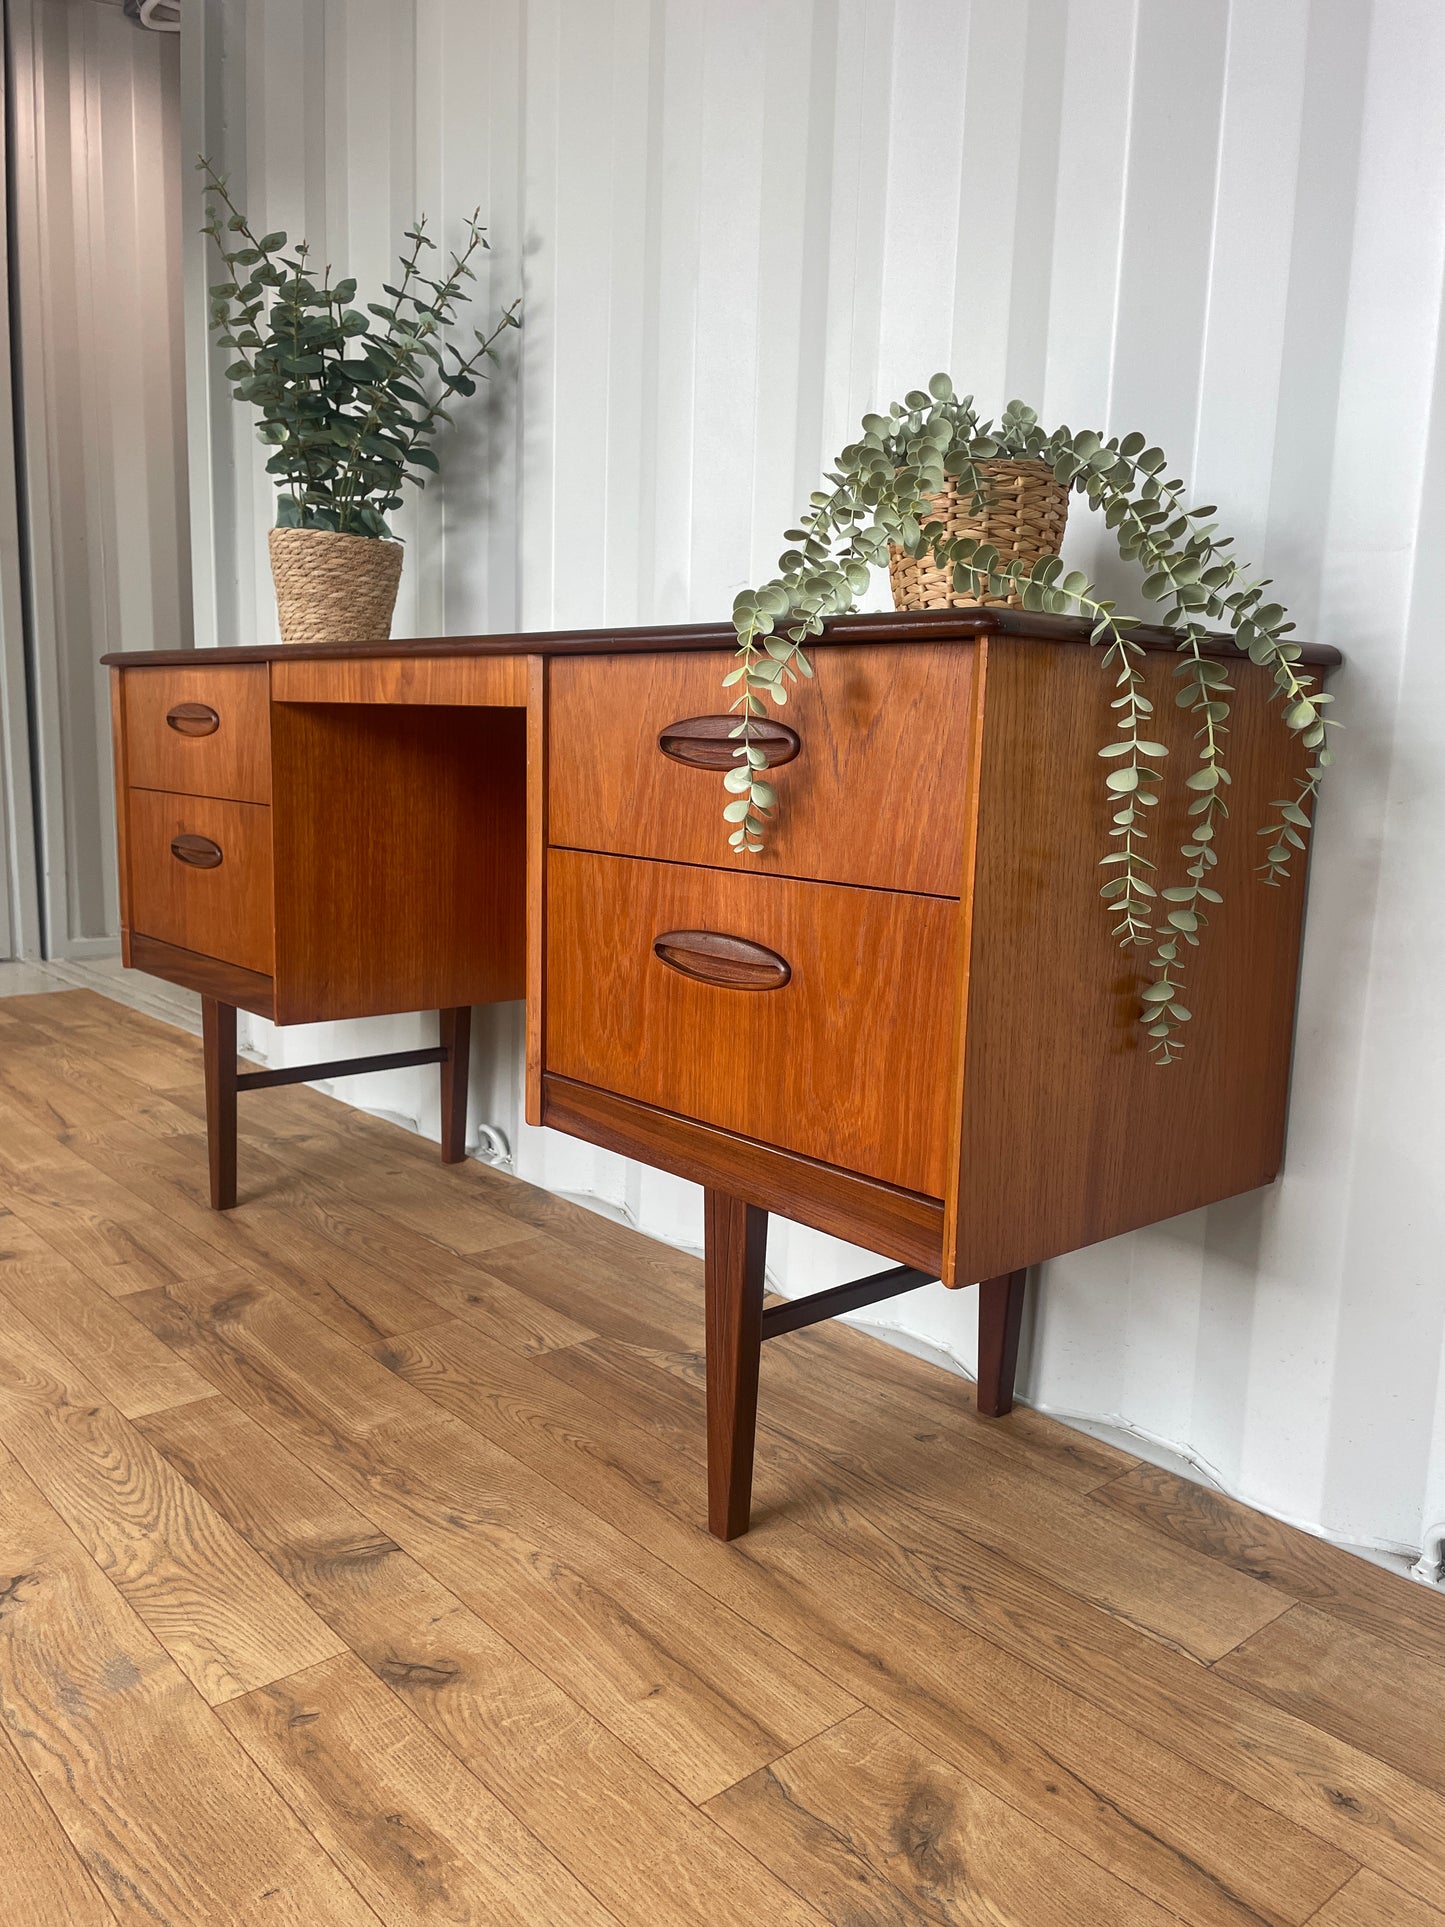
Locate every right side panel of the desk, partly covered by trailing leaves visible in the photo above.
<box><xmin>946</xmin><ymin>638</ymin><xmax>1325</xmax><ymax>1283</ymax></box>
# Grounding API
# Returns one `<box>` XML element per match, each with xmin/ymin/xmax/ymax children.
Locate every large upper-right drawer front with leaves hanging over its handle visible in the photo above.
<box><xmin>547</xmin><ymin>642</ymin><xmax>977</xmax><ymax>896</ymax></box>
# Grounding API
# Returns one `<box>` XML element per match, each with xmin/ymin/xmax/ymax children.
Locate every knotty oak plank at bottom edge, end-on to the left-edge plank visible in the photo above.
<box><xmin>220</xmin><ymin>1653</ymin><xmax>615</xmax><ymax>1927</ymax></box>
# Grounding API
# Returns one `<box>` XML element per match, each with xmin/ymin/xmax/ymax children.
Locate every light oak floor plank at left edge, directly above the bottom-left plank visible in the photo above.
<box><xmin>0</xmin><ymin>1297</ymin><xmax>341</xmax><ymax>1703</ymax></box>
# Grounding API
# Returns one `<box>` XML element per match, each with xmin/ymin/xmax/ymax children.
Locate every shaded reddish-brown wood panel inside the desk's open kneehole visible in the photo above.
<box><xmin>272</xmin><ymin>703</ymin><xmax>526</xmax><ymax>1023</ymax></box>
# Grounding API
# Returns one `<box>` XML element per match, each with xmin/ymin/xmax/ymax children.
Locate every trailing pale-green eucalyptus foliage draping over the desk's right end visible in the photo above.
<box><xmin>723</xmin><ymin>374</ymin><xmax>1335</xmax><ymax>1064</ymax></box>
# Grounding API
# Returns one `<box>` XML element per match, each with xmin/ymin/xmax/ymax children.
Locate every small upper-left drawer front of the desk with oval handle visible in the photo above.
<box><xmin>121</xmin><ymin>663</ymin><xmax>272</xmax><ymax>804</ymax></box>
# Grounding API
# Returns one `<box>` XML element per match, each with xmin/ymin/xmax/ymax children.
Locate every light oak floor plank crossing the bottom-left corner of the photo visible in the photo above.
<box><xmin>0</xmin><ymin>1449</ymin><xmax>376</xmax><ymax>1927</ymax></box>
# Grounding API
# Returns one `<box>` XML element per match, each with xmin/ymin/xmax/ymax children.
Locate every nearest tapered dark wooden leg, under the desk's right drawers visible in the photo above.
<box><xmin>703</xmin><ymin>1191</ymin><xmax>767</xmax><ymax>1540</ymax></box>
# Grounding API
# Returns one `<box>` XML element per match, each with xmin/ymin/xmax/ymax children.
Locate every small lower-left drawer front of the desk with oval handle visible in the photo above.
<box><xmin>129</xmin><ymin>790</ymin><xmax>274</xmax><ymax>977</ymax></box>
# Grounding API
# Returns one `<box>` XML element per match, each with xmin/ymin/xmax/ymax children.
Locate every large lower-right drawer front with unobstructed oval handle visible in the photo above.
<box><xmin>543</xmin><ymin>850</ymin><xmax>959</xmax><ymax>1197</ymax></box>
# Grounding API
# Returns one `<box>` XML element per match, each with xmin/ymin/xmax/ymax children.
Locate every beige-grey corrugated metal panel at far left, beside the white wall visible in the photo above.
<box><xmin>8</xmin><ymin>0</ymin><xmax>191</xmax><ymax>958</ymax></box>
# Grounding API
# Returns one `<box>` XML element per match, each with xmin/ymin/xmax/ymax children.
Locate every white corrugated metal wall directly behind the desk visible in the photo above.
<box><xmin>183</xmin><ymin>0</ymin><xmax>1445</xmax><ymax>1549</ymax></box>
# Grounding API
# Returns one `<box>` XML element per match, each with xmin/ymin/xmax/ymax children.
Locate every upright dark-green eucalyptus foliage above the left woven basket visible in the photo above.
<box><xmin>198</xmin><ymin>158</ymin><xmax>522</xmax><ymax>536</ymax></box>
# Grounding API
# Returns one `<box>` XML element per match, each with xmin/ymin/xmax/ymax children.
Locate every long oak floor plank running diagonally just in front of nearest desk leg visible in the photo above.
<box><xmin>364</xmin><ymin>1328</ymin><xmax>1353</xmax><ymax>1923</ymax></box>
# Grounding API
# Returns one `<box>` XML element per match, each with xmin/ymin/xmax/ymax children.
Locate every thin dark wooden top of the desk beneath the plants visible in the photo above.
<box><xmin>100</xmin><ymin>609</ymin><xmax>1343</xmax><ymax>671</ymax></box>
